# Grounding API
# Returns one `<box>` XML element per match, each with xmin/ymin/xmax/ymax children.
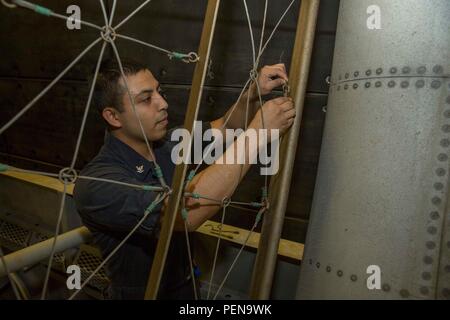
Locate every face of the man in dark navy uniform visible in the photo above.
<box><xmin>119</xmin><ymin>70</ymin><xmax>168</xmax><ymax>141</ymax></box>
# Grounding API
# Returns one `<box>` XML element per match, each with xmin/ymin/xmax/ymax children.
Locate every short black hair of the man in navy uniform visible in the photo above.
<box><xmin>92</xmin><ymin>59</ymin><xmax>148</xmax><ymax>115</ymax></box>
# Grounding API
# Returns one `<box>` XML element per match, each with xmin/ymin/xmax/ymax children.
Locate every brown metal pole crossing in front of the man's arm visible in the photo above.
<box><xmin>145</xmin><ymin>0</ymin><xmax>220</xmax><ymax>300</ymax></box>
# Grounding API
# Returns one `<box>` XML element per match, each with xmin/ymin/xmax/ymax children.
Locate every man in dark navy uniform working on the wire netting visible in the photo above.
<box><xmin>74</xmin><ymin>58</ymin><xmax>295</xmax><ymax>299</ymax></box>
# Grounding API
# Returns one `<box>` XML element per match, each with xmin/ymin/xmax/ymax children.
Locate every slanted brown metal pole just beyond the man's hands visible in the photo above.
<box><xmin>250</xmin><ymin>0</ymin><xmax>320</xmax><ymax>299</ymax></box>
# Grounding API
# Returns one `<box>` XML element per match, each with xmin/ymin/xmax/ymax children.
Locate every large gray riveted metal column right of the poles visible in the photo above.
<box><xmin>297</xmin><ymin>0</ymin><xmax>450</xmax><ymax>299</ymax></box>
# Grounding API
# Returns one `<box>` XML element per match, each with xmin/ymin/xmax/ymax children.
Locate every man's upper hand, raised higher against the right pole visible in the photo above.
<box><xmin>250</xmin><ymin>63</ymin><xmax>288</xmax><ymax>100</ymax></box>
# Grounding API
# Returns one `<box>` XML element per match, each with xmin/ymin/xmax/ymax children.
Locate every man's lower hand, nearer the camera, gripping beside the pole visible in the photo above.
<box><xmin>250</xmin><ymin>97</ymin><xmax>295</xmax><ymax>136</ymax></box>
